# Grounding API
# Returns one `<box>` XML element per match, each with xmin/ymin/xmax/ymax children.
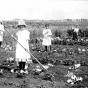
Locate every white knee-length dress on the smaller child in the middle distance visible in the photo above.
<box><xmin>42</xmin><ymin>29</ymin><xmax>52</xmax><ymax>46</ymax></box>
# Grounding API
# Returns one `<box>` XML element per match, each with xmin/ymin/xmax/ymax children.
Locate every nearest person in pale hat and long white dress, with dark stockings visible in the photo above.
<box><xmin>16</xmin><ymin>20</ymin><xmax>31</xmax><ymax>73</ymax></box>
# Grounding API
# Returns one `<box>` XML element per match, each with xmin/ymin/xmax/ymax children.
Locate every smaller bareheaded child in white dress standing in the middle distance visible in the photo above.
<box><xmin>42</xmin><ymin>24</ymin><xmax>52</xmax><ymax>51</ymax></box>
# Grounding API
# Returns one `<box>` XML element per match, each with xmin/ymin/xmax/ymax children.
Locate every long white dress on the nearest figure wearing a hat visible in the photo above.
<box><xmin>16</xmin><ymin>29</ymin><xmax>31</xmax><ymax>61</ymax></box>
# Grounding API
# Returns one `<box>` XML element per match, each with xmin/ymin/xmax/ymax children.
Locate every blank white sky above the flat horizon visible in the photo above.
<box><xmin>0</xmin><ymin>0</ymin><xmax>88</xmax><ymax>20</ymax></box>
